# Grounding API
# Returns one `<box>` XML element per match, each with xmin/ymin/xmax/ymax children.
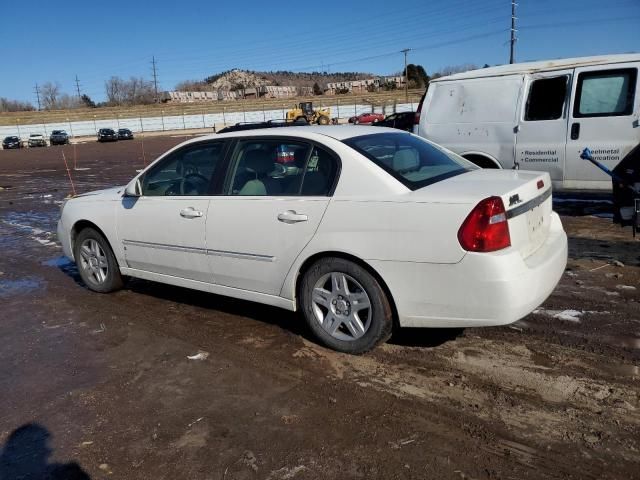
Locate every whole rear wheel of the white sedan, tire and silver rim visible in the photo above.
<box><xmin>300</xmin><ymin>258</ymin><xmax>393</xmax><ymax>354</ymax></box>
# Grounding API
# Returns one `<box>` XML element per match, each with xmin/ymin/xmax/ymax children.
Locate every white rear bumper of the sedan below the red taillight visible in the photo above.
<box><xmin>370</xmin><ymin>213</ymin><xmax>567</xmax><ymax>328</ymax></box>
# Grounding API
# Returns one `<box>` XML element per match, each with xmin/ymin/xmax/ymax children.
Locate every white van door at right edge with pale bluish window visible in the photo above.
<box><xmin>564</xmin><ymin>63</ymin><xmax>640</xmax><ymax>190</ymax></box>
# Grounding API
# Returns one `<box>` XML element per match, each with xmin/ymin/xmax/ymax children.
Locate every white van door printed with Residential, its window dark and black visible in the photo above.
<box><xmin>515</xmin><ymin>69</ymin><xmax>573</xmax><ymax>186</ymax></box>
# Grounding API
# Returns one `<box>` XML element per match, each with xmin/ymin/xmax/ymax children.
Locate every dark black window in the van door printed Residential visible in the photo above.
<box><xmin>524</xmin><ymin>75</ymin><xmax>569</xmax><ymax>121</ymax></box>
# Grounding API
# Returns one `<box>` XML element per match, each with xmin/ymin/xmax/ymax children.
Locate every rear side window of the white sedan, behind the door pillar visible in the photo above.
<box><xmin>226</xmin><ymin>139</ymin><xmax>338</xmax><ymax>196</ymax></box>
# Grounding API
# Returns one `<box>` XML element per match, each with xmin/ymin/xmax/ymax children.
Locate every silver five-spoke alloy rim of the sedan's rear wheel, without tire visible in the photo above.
<box><xmin>311</xmin><ymin>272</ymin><xmax>372</xmax><ymax>341</ymax></box>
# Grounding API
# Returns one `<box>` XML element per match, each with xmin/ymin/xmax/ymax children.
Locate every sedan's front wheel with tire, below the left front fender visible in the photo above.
<box><xmin>73</xmin><ymin>228</ymin><xmax>123</xmax><ymax>293</ymax></box>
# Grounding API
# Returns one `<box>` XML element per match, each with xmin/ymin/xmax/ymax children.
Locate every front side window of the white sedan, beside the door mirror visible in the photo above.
<box><xmin>142</xmin><ymin>142</ymin><xmax>225</xmax><ymax>197</ymax></box>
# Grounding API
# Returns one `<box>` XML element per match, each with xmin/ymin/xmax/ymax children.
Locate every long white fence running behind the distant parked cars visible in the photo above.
<box><xmin>0</xmin><ymin>101</ymin><xmax>416</xmax><ymax>140</ymax></box>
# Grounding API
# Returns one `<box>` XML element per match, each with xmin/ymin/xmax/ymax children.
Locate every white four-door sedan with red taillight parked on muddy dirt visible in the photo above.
<box><xmin>58</xmin><ymin>126</ymin><xmax>567</xmax><ymax>353</ymax></box>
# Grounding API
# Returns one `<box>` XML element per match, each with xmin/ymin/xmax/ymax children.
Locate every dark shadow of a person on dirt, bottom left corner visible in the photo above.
<box><xmin>0</xmin><ymin>423</ymin><xmax>91</xmax><ymax>480</ymax></box>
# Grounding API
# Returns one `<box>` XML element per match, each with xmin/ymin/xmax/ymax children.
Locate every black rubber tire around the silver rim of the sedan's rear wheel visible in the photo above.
<box><xmin>299</xmin><ymin>257</ymin><xmax>393</xmax><ymax>355</ymax></box>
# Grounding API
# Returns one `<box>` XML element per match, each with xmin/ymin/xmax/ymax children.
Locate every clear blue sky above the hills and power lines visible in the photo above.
<box><xmin>0</xmin><ymin>0</ymin><xmax>640</xmax><ymax>103</ymax></box>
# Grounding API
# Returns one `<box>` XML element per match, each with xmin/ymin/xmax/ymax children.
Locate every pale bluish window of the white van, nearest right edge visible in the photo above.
<box><xmin>573</xmin><ymin>68</ymin><xmax>638</xmax><ymax>118</ymax></box>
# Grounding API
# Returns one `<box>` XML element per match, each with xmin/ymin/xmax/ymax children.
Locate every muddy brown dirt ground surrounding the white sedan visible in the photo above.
<box><xmin>0</xmin><ymin>137</ymin><xmax>640</xmax><ymax>480</ymax></box>
